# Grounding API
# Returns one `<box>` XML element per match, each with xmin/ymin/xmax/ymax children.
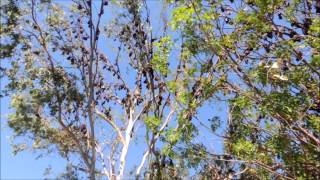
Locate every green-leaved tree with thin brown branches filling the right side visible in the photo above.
<box><xmin>165</xmin><ymin>0</ymin><xmax>320</xmax><ymax>179</ymax></box>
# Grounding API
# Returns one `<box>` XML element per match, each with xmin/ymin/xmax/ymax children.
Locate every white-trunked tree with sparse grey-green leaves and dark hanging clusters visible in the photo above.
<box><xmin>1</xmin><ymin>0</ymin><xmax>177</xmax><ymax>179</ymax></box>
